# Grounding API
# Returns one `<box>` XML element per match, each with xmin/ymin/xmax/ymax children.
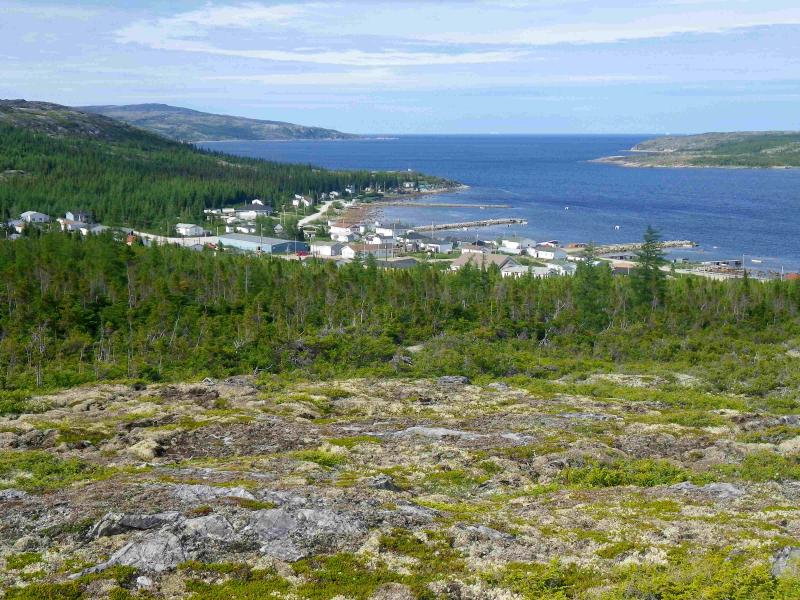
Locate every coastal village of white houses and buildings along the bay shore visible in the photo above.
<box><xmin>5</xmin><ymin>197</ymin><xmax>800</xmax><ymax>280</ymax></box>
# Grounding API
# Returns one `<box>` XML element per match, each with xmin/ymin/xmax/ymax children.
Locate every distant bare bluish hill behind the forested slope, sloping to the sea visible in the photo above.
<box><xmin>78</xmin><ymin>104</ymin><xmax>358</xmax><ymax>142</ymax></box>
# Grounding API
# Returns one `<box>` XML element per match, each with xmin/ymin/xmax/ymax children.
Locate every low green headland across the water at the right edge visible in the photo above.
<box><xmin>598</xmin><ymin>131</ymin><xmax>800</xmax><ymax>168</ymax></box>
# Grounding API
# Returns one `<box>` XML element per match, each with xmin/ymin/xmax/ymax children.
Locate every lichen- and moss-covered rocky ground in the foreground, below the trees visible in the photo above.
<box><xmin>0</xmin><ymin>375</ymin><xmax>800</xmax><ymax>599</ymax></box>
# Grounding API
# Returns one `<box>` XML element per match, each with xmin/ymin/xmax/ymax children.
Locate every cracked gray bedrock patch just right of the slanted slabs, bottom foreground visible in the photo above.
<box><xmin>248</xmin><ymin>508</ymin><xmax>367</xmax><ymax>561</ymax></box>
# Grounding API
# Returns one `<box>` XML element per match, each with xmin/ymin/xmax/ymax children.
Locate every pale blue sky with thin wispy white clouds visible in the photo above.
<box><xmin>0</xmin><ymin>0</ymin><xmax>800</xmax><ymax>134</ymax></box>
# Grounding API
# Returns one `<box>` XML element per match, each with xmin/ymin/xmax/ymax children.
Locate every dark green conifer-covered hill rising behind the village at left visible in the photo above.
<box><xmin>0</xmin><ymin>100</ymin><xmax>441</xmax><ymax>232</ymax></box>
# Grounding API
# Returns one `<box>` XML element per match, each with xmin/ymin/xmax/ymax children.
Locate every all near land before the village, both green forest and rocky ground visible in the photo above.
<box><xmin>0</xmin><ymin>232</ymin><xmax>800</xmax><ymax>600</ymax></box>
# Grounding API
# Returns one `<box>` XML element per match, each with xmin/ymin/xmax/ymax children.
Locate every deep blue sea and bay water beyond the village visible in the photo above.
<box><xmin>203</xmin><ymin>135</ymin><xmax>800</xmax><ymax>270</ymax></box>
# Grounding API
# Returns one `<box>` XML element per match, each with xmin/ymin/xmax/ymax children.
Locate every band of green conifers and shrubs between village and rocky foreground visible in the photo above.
<box><xmin>0</xmin><ymin>234</ymin><xmax>800</xmax><ymax>402</ymax></box>
